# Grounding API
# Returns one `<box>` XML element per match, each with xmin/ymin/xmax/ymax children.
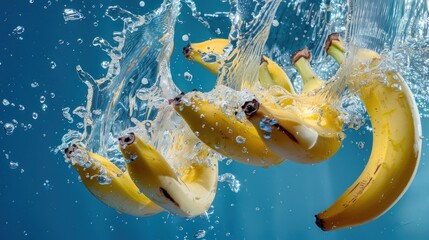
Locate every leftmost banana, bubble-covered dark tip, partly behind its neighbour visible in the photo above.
<box><xmin>65</xmin><ymin>144</ymin><xmax>163</xmax><ymax>217</ymax></box>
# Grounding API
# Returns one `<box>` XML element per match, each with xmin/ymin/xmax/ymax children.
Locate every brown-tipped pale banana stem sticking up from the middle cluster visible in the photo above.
<box><xmin>292</xmin><ymin>47</ymin><xmax>324</xmax><ymax>93</ymax></box>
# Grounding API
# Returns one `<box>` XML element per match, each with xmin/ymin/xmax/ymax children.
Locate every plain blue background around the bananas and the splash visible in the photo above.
<box><xmin>0</xmin><ymin>0</ymin><xmax>429</xmax><ymax>239</ymax></box>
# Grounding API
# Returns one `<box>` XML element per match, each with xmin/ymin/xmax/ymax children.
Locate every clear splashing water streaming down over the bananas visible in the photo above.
<box><xmin>57</xmin><ymin>0</ymin><xmax>429</xmax><ymax>221</ymax></box>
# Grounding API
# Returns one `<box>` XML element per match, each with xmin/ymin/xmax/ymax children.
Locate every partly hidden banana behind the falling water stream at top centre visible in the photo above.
<box><xmin>183</xmin><ymin>38</ymin><xmax>295</xmax><ymax>93</ymax></box>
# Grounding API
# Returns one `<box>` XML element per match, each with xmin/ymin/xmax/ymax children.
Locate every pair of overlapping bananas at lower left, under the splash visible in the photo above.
<box><xmin>65</xmin><ymin>121</ymin><xmax>218</xmax><ymax>217</ymax></box>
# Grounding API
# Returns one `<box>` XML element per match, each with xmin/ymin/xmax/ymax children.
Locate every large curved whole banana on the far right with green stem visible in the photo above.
<box><xmin>316</xmin><ymin>34</ymin><xmax>422</xmax><ymax>231</ymax></box>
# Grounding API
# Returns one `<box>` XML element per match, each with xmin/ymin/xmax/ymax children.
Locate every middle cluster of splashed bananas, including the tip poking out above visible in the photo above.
<box><xmin>179</xmin><ymin>39</ymin><xmax>342</xmax><ymax>167</ymax></box>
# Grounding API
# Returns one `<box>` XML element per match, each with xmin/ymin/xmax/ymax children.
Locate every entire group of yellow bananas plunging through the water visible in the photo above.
<box><xmin>66</xmin><ymin>34</ymin><xmax>422</xmax><ymax>231</ymax></box>
